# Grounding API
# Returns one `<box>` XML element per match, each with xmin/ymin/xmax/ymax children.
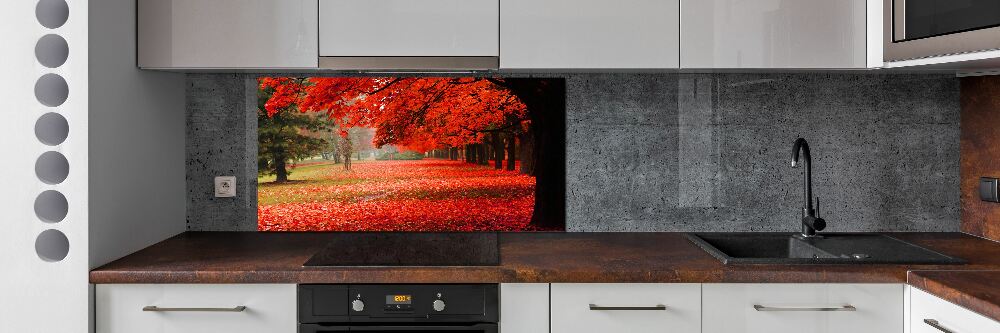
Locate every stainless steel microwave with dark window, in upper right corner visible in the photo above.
<box><xmin>883</xmin><ymin>0</ymin><xmax>1000</xmax><ymax>61</ymax></box>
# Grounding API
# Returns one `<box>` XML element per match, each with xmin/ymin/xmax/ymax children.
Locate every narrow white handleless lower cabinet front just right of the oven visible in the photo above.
<box><xmin>500</xmin><ymin>283</ymin><xmax>549</xmax><ymax>333</ymax></box>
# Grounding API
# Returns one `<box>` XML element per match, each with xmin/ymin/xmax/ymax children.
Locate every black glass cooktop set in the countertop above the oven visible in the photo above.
<box><xmin>303</xmin><ymin>232</ymin><xmax>500</xmax><ymax>267</ymax></box>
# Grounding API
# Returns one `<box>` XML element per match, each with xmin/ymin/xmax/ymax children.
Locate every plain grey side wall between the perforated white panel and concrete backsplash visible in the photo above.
<box><xmin>89</xmin><ymin>0</ymin><xmax>186</xmax><ymax>268</ymax></box>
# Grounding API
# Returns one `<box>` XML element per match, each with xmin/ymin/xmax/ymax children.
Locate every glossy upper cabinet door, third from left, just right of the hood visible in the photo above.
<box><xmin>500</xmin><ymin>0</ymin><xmax>679</xmax><ymax>69</ymax></box>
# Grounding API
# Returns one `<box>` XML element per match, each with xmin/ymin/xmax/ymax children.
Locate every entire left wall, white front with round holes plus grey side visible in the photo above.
<box><xmin>0</xmin><ymin>0</ymin><xmax>185</xmax><ymax>333</ymax></box>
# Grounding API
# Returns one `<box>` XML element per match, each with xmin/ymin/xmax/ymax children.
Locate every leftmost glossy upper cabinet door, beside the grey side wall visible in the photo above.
<box><xmin>138</xmin><ymin>0</ymin><xmax>318</xmax><ymax>68</ymax></box>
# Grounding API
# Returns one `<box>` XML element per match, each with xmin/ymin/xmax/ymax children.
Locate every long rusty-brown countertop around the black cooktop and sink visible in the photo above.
<box><xmin>90</xmin><ymin>232</ymin><xmax>1000</xmax><ymax>284</ymax></box>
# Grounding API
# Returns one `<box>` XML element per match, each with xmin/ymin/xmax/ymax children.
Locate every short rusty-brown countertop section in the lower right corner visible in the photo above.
<box><xmin>906</xmin><ymin>270</ymin><xmax>1000</xmax><ymax>321</ymax></box>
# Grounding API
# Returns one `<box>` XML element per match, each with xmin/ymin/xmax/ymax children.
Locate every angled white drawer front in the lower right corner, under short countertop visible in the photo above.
<box><xmin>909</xmin><ymin>288</ymin><xmax>1000</xmax><ymax>333</ymax></box>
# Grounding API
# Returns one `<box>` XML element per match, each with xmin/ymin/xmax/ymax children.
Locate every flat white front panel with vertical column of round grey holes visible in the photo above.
<box><xmin>0</xmin><ymin>0</ymin><xmax>90</xmax><ymax>333</ymax></box>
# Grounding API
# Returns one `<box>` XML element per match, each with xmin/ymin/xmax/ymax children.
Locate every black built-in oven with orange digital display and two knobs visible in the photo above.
<box><xmin>298</xmin><ymin>284</ymin><xmax>500</xmax><ymax>333</ymax></box>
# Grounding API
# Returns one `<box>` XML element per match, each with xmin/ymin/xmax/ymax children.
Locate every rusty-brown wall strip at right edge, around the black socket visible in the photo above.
<box><xmin>961</xmin><ymin>76</ymin><xmax>1000</xmax><ymax>241</ymax></box>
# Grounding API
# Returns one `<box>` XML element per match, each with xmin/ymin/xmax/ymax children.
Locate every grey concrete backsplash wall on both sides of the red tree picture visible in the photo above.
<box><xmin>187</xmin><ymin>73</ymin><xmax>960</xmax><ymax>231</ymax></box>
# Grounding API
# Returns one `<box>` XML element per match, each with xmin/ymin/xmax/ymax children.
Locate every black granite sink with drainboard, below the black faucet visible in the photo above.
<box><xmin>687</xmin><ymin>233</ymin><xmax>965</xmax><ymax>265</ymax></box>
